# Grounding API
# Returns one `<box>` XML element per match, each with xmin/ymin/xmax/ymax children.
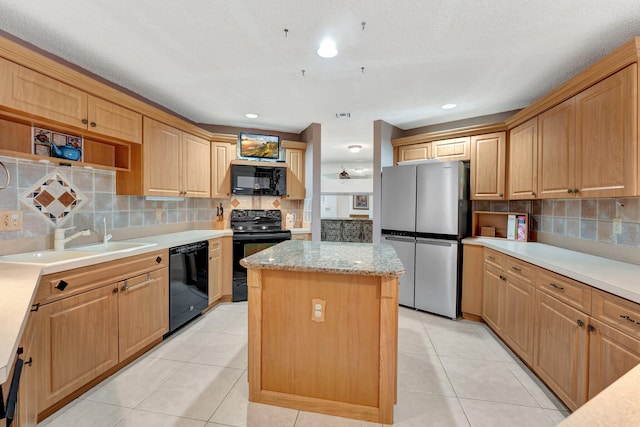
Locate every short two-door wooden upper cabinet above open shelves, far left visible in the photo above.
<box><xmin>0</xmin><ymin>58</ymin><xmax>142</xmax><ymax>143</ymax></box>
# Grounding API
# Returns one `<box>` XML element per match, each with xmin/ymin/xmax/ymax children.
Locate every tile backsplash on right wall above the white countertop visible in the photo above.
<box><xmin>473</xmin><ymin>197</ymin><xmax>640</xmax><ymax>247</ymax></box>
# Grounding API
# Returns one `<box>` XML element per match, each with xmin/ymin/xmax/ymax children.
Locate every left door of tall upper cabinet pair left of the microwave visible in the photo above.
<box><xmin>143</xmin><ymin>117</ymin><xmax>182</xmax><ymax>197</ymax></box>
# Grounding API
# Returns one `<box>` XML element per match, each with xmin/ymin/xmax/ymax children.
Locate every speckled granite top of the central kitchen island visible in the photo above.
<box><xmin>240</xmin><ymin>240</ymin><xmax>405</xmax><ymax>276</ymax></box>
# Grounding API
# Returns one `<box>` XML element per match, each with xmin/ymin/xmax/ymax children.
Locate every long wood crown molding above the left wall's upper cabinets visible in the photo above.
<box><xmin>0</xmin><ymin>37</ymin><xmax>212</xmax><ymax>140</ymax></box>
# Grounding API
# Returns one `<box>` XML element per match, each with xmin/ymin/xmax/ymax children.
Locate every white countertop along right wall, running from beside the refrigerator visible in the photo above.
<box><xmin>462</xmin><ymin>237</ymin><xmax>640</xmax><ymax>304</ymax></box>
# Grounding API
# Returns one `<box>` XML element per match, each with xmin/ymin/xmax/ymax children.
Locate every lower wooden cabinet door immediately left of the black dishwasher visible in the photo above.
<box><xmin>118</xmin><ymin>268</ymin><xmax>169</xmax><ymax>361</ymax></box>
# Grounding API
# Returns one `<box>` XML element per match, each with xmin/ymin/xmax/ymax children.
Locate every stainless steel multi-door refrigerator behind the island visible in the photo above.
<box><xmin>381</xmin><ymin>162</ymin><xmax>470</xmax><ymax>319</ymax></box>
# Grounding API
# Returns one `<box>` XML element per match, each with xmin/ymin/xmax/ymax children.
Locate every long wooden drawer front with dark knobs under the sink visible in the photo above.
<box><xmin>34</xmin><ymin>249</ymin><xmax>169</xmax><ymax>304</ymax></box>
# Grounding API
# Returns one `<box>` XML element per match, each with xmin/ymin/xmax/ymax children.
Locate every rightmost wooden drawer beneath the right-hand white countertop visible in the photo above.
<box><xmin>591</xmin><ymin>289</ymin><xmax>640</xmax><ymax>339</ymax></box>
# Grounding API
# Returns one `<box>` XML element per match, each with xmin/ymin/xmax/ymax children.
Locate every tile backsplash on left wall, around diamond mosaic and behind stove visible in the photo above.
<box><xmin>0</xmin><ymin>156</ymin><xmax>303</xmax><ymax>241</ymax></box>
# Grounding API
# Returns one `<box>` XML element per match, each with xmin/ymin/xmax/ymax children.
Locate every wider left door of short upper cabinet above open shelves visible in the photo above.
<box><xmin>0</xmin><ymin>58</ymin><xmax>87</xmax><ymax>128</ymax></box>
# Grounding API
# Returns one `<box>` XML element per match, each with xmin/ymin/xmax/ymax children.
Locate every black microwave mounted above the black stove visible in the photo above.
<box><xmin>231</xmin><ymin>164</ymin><xmax>287</xmax><ymax>196</ymax></box>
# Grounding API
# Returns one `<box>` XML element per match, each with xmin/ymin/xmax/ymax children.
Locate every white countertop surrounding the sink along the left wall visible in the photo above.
<box><xmin>0</xmin><ymin>230</ymin><xmax>233</xmax><ymax>384</ymax></box>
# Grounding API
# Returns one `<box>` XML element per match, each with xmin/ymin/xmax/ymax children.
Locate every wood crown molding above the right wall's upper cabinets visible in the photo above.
<box><xmin>506</xmin><ymin>37</ymin><xmax>640</xmax><ymax>129</ymax></box>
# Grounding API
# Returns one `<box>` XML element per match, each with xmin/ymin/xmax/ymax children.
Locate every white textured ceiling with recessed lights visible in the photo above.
<box><xmin>0</xmin><ymin>0</ymin><xmax>640</xmax><ymax>162</ymax></box>
